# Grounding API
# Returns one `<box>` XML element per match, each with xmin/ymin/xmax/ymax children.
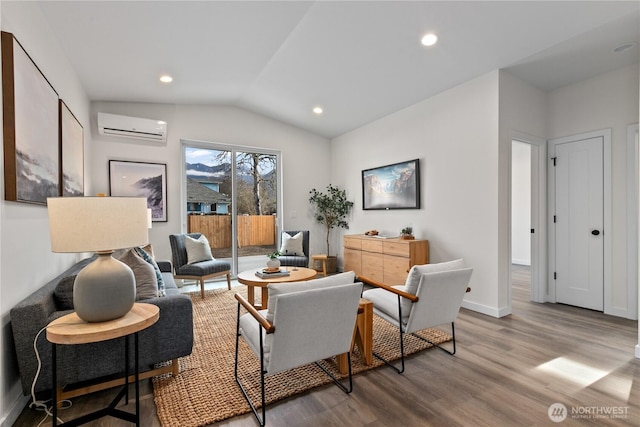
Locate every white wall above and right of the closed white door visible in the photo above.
<box><xmin>548</xmin><ymin>65</ymin><xmax>639</xmax><ymax>318</ymax></box>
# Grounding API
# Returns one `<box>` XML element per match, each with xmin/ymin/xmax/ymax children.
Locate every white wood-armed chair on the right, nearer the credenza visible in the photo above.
<box><xmin>358</xmin><ymin>259</ymin><xmax>473</xmax><ymax>374</ymax></box>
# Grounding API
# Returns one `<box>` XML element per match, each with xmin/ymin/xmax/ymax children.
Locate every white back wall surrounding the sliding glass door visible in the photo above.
<box><xmin>89</xmin><ymin>102</ymin><xmax>331</xmax><ymax>259</ymax></box>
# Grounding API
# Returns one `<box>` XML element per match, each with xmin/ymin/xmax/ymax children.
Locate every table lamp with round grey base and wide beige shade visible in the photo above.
<box><xmin>47</xmin><ymin>197</ymin><xmax>149</xmax><ymax>322</ymax></box>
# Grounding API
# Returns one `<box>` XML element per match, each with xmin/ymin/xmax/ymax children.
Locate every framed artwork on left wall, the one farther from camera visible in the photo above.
<box><xmin>60</xmin><ymin>100</ymin><xmax>84</xmax><ymax>197</ymax></box>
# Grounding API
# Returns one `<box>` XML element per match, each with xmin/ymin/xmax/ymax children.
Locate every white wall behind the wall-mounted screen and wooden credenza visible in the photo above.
<box><xmin>331</xmin><ymin>71</ymin><xmax>502</xmax><ymax>316</ymax></box>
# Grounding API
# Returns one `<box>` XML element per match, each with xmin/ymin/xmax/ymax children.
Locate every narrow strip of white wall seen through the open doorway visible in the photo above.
<box><xmin>511</xmin><ymin>141</ymin><xmax>531</xmax><ymax>265</ymax></box>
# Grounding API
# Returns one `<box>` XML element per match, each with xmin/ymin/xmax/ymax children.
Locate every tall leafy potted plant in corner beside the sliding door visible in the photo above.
<box><xmin>309</xmin><ymin>184</ymin><xmax>353</xmax><ymax>273</ymax></box>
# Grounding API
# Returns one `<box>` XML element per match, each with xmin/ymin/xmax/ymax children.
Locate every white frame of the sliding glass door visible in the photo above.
<box><xmin>180</xmin><ymin>139</ymin><xmax>283</xmax><ymax>277</ymax></box>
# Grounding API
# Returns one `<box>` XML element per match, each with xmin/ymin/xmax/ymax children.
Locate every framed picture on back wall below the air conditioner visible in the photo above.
<box><xmin>109</xmin><ymin>160</ymin><xmax>167</xmax><ymax>222</ymax></box>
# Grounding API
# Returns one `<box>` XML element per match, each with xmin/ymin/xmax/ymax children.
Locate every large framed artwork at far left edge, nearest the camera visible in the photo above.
<box><xmin>1</xmin><ymin>31</ymin><xmax>60</xmax><ymax>205</ymax></box>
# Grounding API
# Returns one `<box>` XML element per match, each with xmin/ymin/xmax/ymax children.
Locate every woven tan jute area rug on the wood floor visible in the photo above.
<box><xmin>153</xmin><ymin>286</ymin><xmax>451</xmax><ymax>427</ymax></box>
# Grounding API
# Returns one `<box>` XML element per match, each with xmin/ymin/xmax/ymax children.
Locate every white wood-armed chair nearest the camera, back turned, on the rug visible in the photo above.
<box><xmin>234</xmin><ymin>272</ymin><xmax>362</xmax><ymax>426</ymax></box>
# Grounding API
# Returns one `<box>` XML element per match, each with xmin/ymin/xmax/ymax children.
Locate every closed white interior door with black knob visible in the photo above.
<box><xmin>555</xmin><ymin>137</ymin><xmax>606</xmax><ymax>311</ymax></box>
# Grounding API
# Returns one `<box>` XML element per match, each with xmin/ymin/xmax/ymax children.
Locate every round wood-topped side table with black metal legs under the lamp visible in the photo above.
<box><xmin>47</xmin><ymin>303</ymin><xmax>160</xmax><ymax>426</ymax></box>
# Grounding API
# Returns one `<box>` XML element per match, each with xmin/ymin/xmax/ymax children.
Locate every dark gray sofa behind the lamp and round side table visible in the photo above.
<box><xmin>11</xmin><ymin>256</ymin><xmax>193</xmax><ymax>398</ymax></box>
